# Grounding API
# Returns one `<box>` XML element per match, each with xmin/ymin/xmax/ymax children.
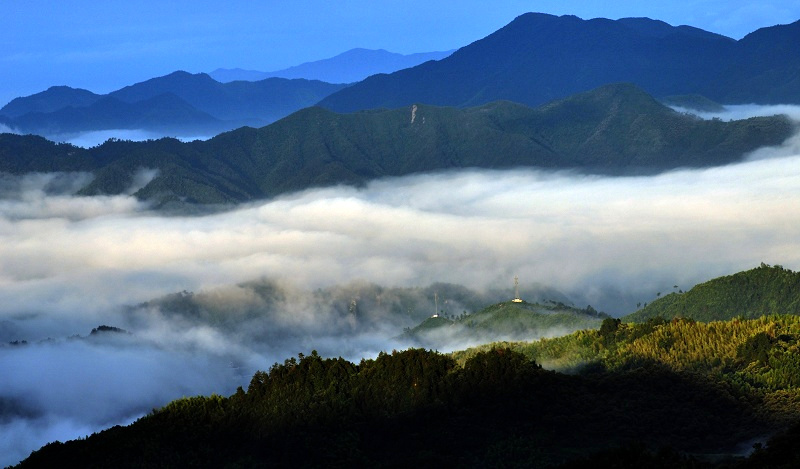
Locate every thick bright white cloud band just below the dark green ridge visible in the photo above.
<box><xmin>6</xmin><ymin>154</ymin><xmax>800</xmax><ymax>326</ymax></box>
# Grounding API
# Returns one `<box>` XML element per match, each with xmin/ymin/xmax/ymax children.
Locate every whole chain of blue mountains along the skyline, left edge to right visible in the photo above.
<box><xmin>0</xmin><ymin>13</ymin><xmax>800</xmax><ymax>140</ymax></box>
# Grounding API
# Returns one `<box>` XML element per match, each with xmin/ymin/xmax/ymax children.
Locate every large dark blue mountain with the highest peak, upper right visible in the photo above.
<box><xmin>320</xmin><ymin>13</ymin><xmax>800</xmax><ymax>112</ymax></box>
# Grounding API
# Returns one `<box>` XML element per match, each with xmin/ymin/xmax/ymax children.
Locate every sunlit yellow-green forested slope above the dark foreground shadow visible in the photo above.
<box><xmin>453</xmin><ymin>315</ymin><xmax>800</xmax><ymax>400</ymax></box>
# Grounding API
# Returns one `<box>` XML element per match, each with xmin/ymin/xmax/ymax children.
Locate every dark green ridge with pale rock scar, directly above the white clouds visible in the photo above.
<box><xmin>0</xmin><ymin>84</ymin><xmax>794</xmax><ymax>206</ymax></box>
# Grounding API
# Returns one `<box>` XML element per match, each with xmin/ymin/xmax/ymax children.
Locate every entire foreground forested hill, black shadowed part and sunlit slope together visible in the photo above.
<box><xmin>19</xmin><ymin>316</ymin><xmax>800</xmax><ymax>468</ymax></box>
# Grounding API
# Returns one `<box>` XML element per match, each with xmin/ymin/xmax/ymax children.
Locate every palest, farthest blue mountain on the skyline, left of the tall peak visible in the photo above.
<box><xmin>209</xmin><ymin>48</ymin><xmax>454</xmax><ymax>83</ymax></box>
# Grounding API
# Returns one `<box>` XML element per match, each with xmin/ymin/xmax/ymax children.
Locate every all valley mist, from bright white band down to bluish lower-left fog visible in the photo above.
<box><xmin>0</xmin><ymin>107</ymin><xmax>800</xmax><ymax>464</ymax></box>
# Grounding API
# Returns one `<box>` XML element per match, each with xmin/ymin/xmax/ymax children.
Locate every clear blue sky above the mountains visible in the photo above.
<box><xmin>0</xmin><ymin>0</ymin><xmax>800</xmax><ymax>105</ymax></box>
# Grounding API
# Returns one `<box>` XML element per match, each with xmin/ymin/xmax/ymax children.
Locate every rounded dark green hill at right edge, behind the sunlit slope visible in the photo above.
<box><xmin>623</xmin><ymin>263</ymin><xmax>800</xmax><ymax>322</ymax></box>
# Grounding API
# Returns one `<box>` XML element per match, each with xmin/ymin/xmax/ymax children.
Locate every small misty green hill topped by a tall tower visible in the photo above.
<box><xmin>399</xmin><ymin>300</ymin><xmax>609</xmax><ymax>349</ymax></box>
